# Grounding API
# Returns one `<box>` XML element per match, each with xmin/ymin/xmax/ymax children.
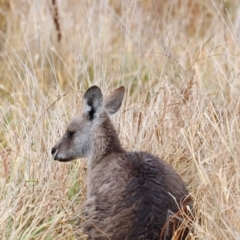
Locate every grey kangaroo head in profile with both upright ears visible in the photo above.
<box><xmin>51</xmin><ymin>86</ymin><xmax>125</xmax><ymax>162</ymax></box>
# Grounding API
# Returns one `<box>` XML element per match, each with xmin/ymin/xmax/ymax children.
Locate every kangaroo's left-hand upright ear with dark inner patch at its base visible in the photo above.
<box><xmin>84</xmin><ymin>86</ymin><xmax>103</xmax><ymax>121</ymax></box>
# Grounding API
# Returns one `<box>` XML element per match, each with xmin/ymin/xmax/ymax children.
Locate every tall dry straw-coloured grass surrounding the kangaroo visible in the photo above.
<box><xmin>0</xmin><ymin>0</ymin><xmax>240</xmax><ymax>240</ymax></box>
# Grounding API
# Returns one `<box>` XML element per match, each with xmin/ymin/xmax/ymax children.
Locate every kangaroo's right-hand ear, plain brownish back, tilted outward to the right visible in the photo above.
<box><xmin>104</xmin><ymin>86</ymin><xmax>125</xmax><ymax>114</ymax></box>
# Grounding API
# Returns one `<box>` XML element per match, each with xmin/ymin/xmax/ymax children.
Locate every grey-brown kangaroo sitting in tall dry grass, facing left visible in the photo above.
<box><xmin>51</xmin><ymin>86</ymin><xmax>191</xmax><ymax>240</ymax></box>
